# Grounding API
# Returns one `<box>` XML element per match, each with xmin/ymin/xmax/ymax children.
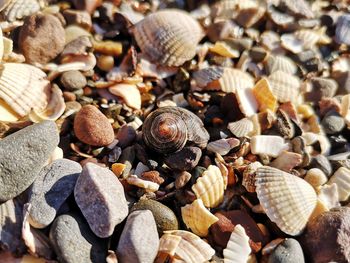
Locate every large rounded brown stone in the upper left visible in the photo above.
<box><xmin>18</xmin><ymin>14</ymin><xmax>66</xmax><ymax>64</ymax></box>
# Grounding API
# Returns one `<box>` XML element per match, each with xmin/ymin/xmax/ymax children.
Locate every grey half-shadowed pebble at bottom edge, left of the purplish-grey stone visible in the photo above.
<box><xmin>50</xmin><ymin>214</ymin><xmax>107</xmax><ymax>263</ymax></box>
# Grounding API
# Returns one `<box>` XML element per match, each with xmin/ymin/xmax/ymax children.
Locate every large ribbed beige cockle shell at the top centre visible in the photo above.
<box><xmin>132</xmin><ymin>10</ymin><xmax>203</xmax><ymax>66</ymax></box>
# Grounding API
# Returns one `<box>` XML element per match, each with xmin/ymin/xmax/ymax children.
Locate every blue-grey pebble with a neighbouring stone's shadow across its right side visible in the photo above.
<box><xmin>29</xmin><ymin>159</ymin><xmax>82</xmax><ymax>228</ymax></box>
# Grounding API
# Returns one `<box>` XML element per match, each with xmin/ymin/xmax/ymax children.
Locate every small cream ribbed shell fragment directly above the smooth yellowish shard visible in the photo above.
<box><xmin>192</xmin><ymin>165</ymin><xmax>225</xmax><ymax>208</ymax></box>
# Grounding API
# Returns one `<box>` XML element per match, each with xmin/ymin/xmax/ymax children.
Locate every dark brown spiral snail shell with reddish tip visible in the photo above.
<box><xmin>142</xmin><ymin>106</ymin><xmax>209</xmax><ymax>154</ymax></box>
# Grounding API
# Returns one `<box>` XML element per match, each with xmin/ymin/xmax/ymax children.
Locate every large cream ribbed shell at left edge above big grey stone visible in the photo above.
<box><xmin>0</xmin><ymin>63</ymin><xmax>50</xmax><ymax>117</ymax></box>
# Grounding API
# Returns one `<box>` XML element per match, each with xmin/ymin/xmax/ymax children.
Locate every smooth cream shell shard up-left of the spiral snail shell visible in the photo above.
<box><xmin>108</xmin><ymin>84</ymin><xmax>141</xmax><ymax>110</ymax></box>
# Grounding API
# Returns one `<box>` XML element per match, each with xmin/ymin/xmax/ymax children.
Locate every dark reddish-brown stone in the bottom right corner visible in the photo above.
<box><xmin>300</xmin><ymin>207</ymin><xmax>350</xmax><ymax>263</ymax></box>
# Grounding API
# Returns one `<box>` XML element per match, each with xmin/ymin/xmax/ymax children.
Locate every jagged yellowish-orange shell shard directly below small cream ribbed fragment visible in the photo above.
<box><xmin>181</xmin><ymin>199</ymin><xmax>219</xmax><ymax>237</ymax></box>
